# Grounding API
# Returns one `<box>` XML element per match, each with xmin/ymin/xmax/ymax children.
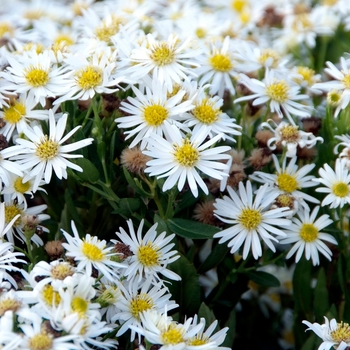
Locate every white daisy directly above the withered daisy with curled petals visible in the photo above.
<box><xmin>234</xmin><ymin>69</ymin><xmax>312</xmax><ymax>125</ymax></box>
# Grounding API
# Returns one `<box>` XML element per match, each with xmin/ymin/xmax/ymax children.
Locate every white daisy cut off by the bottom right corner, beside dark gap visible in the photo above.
<box><xmin>303</xmin><ymin>317</ymin><xmax>350</xmax><ymax>350</ymax></box>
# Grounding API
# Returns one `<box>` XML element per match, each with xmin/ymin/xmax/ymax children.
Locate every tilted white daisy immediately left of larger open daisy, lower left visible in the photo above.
<box><xmin>62</xmin><ymin>221</ymin><xmax>126</xmax><ymax>282</ymax></box>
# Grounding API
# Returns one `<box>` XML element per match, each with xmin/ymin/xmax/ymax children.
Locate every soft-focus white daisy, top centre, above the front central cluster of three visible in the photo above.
<box><xmin>196</xmin><ymin>36</ymin><xmax>238</xmax><ymax>97</ymax></box>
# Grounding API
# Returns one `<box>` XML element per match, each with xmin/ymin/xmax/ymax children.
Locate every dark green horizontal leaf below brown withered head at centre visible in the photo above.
<box><xmin>168</xmin><ymin>218</ymin><xmax>219</xmax><ymax>239</ymax></box>
